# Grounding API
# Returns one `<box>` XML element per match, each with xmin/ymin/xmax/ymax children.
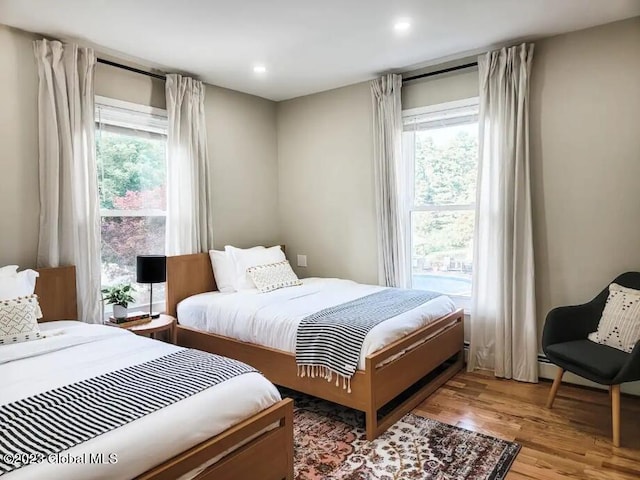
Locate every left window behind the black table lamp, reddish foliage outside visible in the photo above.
<box><xmin>96</xmin><ymin>97</ymin><xmax>167</xmax><ymax>307</ymax></box>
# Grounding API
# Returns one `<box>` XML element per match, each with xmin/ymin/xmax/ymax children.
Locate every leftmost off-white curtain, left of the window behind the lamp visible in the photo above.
<box><xmin>34</xmin><ymin>40</ymin><xmax>102</xmax><ymax>323</ymax></box>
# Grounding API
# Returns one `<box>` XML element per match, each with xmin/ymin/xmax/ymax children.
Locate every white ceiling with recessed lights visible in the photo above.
<box><xmin>0</xmin><ymin>0</ymin><xmax>640</xmax><ymax>100</ymax></box>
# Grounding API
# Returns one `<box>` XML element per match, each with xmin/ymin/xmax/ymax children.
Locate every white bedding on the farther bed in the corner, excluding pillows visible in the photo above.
<box><xmin>178</xmin><ymin>278</ymin><xmax>455</xmax><ymax>369</ymax></box>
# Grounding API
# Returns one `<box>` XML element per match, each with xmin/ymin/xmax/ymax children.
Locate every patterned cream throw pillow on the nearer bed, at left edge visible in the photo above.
<box><xmin>0</xmin><ymin>295</ymin><xmax>42</xmax><ymax>345</ymax></box>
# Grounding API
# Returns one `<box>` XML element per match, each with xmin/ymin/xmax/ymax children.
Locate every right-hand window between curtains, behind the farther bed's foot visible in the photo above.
<box><xmin>403</xmin><ymin>98</ymin><xmax>478</xmax><ymax>308</ymax></box>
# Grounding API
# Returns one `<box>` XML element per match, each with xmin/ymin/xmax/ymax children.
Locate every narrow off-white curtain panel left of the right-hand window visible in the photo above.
<box><xmin>371</xmin><ymin>74</ymin><xmax>407</xmax><ymax>287</ymax></box>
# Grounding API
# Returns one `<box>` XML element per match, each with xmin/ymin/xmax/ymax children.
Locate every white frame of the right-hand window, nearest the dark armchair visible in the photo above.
<box><xmin>401</xmin><ymin>97</ymin><xmax>480</xmax><ymax>313</ymax></box>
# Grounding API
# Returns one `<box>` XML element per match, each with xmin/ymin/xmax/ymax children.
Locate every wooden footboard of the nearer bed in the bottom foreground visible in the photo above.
<box><xmin>136</xmin><ymin>399</ymin><xmax>293</xmax><ymax>480</ymax></box>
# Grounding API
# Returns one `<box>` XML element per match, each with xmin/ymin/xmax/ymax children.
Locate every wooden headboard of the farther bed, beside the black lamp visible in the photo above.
<box><xmin>167</xmin><ymin>245</ymin><xmax>285</xmax><ymax>318</ymax></box>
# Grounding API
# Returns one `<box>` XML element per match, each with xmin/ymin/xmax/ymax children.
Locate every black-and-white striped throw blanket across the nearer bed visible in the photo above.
<box><xmin>0</xmin><ymin>349</ymin><xmax>257</xmax><ymax>476</ymax></box>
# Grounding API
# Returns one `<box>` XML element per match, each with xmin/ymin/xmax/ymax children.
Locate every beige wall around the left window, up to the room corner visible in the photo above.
<box><xmin>0</xmin><ymin>25</ymin><xmax>280</xmax><ymax>267</ymax></box>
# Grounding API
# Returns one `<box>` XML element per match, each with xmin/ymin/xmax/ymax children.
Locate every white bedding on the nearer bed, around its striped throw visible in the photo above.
<box><xmin>0</xmin><ymin>321</ymin><xmax>280</xmax><ymax>480</ymax></box>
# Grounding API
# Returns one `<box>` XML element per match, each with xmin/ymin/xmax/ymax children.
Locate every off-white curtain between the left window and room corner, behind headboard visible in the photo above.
<box><xmin>166</xmin><ymin>74</ymin><xmax>213</xmax><ymax>255</ymax></box>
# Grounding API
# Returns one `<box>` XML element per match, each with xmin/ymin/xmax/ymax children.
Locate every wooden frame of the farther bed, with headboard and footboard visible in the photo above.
<box><xmin>167</xmin><ymin>247</ymin><xmax>464</xmax><ymax>440</ymax></box>
